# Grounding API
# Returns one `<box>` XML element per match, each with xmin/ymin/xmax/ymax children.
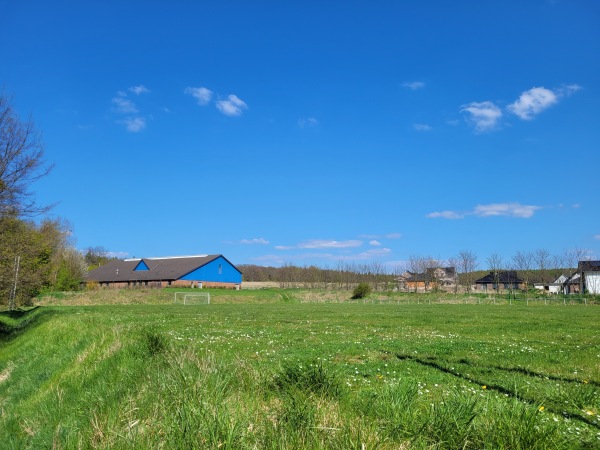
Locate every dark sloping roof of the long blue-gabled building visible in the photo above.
<box><xmin>87</xmin><ymin>255</ymin><xmax>239</xmax><ymax>282</ymax></box>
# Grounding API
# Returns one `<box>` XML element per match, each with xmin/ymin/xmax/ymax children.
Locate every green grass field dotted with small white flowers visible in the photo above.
<box><xmin>0</xmin><ymin>289</ymin><xmax>600</xmax><ymax>449</ymax></box>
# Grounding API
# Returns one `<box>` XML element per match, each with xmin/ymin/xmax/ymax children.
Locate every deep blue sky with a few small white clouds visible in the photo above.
<box><xmin>0</xmin><ymin>0</ymin><xmax>600</xmax><ymax>268</ymax></box>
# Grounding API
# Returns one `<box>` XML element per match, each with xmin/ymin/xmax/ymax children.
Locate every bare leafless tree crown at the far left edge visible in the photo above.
<box><xmin>0</xmin><ymin>92</ymin><xmax>52</xmax><ymax>217</ymax></box>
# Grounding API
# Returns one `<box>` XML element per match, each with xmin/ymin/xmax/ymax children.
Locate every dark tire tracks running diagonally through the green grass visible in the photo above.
<box><xmin>394</xmin><ymin>352</ymin><xmax>600</xmax><ymax>429</ymax></box>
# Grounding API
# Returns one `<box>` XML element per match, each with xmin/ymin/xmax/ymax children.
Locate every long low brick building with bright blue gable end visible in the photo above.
<box><xmin>87</xmin><ymin>255</ymin><xmax>242</xmax><ymax>289</ymax></box>
